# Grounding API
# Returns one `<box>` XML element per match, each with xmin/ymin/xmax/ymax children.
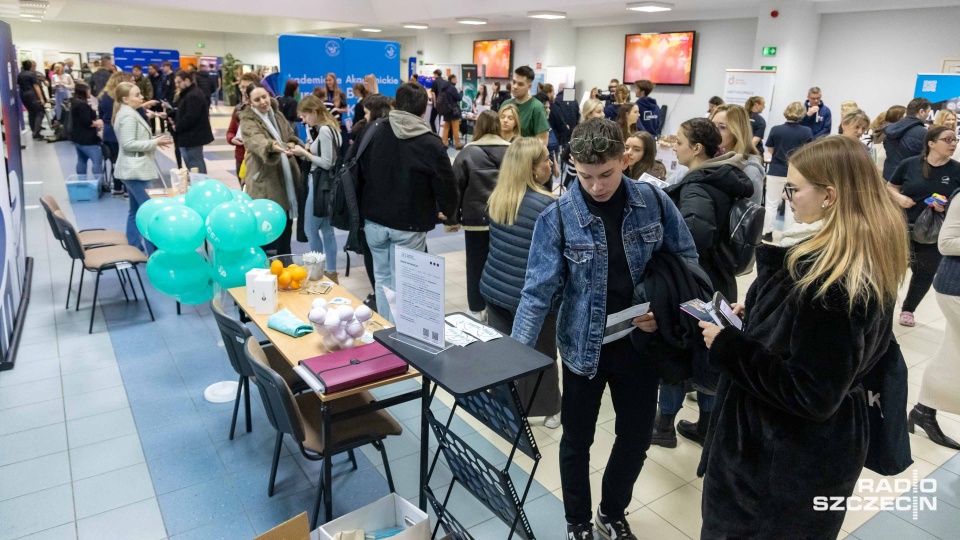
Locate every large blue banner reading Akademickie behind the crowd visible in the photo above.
<box><xmin>279</xmin><ymin>35</ymin><xmax>400</xmax><ymax>126</ymax></box>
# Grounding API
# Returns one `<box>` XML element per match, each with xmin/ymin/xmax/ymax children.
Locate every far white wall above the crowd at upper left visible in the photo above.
<box><xmin>9</xmin><ymin>20</ymin><xmax>280</xmax><ymax>66</ymax></box>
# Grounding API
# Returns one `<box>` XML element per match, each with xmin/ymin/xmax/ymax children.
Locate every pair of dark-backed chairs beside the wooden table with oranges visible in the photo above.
<box><xmin>210</xmin><ymin>298</ymin><xmax>403</xmax><ymax>529</ymax></box>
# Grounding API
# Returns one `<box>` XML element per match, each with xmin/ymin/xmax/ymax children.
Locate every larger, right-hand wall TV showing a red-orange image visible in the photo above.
<box><xmin>623</xmin><ymin>32</ymin><xmax>695</xmax><ymax>86</ymax></box>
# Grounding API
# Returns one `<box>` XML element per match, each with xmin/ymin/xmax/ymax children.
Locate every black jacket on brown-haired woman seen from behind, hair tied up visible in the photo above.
<box><xmin>453</xmin><ymin>135</ymin><xmax>510</xmax><ymax>227</ymax></box>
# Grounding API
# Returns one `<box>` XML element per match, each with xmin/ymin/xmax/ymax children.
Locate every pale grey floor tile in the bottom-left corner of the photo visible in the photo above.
<box><xmin>0</xmin><ymin>484</ymin><xmax>73</xmax><ymax>540</ymax></box>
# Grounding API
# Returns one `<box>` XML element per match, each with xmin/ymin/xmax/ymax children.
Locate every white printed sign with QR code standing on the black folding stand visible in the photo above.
<box><xmin>393</xmin><ymin>247</ymin><xmax>446</xmax><ymax>349</ymax></box>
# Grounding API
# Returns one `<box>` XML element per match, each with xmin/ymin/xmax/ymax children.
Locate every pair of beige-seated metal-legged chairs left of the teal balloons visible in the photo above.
<box><xmin>40</xmin><ymin>195</ymin><xmax>156</xmax><ymax>333</ymax></box>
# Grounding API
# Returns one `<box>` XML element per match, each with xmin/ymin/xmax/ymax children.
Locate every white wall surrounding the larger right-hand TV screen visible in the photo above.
<box><xmin>576</xmin><ymin>19</ymin><xmax>757</xmax><ymax>135</ymax></box>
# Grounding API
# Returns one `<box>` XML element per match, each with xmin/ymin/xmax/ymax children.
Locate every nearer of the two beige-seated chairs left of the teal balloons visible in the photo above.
<box><xmin>54</xmin><ymin>215</ymin><xmax>156</xmax><ymax>334</ymax></box>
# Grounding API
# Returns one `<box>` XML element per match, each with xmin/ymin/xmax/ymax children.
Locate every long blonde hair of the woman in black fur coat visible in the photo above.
<box><xmin>787</xmin><ymin>135</ymin><xmax>910</xmax><ymax>313</ymax></box>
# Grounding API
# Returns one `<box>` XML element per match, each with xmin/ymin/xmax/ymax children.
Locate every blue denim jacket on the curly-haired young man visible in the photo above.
<box><xmin>512</xmin><ymin>176</ymin><xmax>697</xmax><ymax>378</ymax></box>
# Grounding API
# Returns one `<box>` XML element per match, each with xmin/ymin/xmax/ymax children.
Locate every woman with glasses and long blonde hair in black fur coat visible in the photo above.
<box><xmin>697</xmin><ymin>137</ymin><xmax>908</xmax><ymax>539</ymax></box>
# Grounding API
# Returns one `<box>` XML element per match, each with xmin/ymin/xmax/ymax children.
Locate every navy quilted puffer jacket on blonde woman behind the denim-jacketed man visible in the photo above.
<box><xmin>480</xmin><ymin>188</ymin><xmax>555</xmax><ymax>311</ymax></box>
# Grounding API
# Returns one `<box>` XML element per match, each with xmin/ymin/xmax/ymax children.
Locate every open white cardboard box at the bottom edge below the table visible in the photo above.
<box><xmin>319</xmin><ymin>493</ymin><xmax>431</xmax><ymax>540</ymax></box>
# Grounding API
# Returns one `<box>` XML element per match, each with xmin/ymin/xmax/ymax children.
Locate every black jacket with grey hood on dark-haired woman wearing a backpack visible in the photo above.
<box><xmin>665</xmin><ymin>152</ymin><xmax>753</xmax><ymax>302</ymax></box>
